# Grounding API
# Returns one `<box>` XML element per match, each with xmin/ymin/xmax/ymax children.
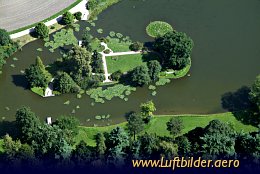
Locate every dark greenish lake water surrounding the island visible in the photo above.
<box><xmin>0</xmin><ymin>0</ymin><xmax>260</xmax><ymax>125</ymax></box>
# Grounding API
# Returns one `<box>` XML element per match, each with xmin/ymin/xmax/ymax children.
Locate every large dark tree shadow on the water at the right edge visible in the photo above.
<box><xmin>221</xmin><ymin>86</ymin><xmax>260</xmax><ymax>126</ymax></box>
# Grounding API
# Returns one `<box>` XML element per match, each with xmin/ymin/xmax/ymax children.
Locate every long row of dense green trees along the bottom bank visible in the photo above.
<box><xmin>0</xmin><ymin>103</ymin><xmax>260</xmax><ymax>171</ymax></box>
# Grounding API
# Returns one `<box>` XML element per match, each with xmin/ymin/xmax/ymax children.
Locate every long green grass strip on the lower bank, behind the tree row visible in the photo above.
<box><xmin>75</xmin><ymin>112</ymin><xmax>258</xmax><ymax>146</ymax></box>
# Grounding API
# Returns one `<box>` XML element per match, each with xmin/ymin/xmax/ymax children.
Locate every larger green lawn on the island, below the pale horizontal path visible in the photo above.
<box><xmin>106</xmin><ymin>54</ymin><xmax>145</xmax><ymax>73</ymax></box>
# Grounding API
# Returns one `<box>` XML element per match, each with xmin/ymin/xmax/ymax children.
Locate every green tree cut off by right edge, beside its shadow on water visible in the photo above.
<box><xmin>249</xmin><ymin>74</ymin><xmax>260</xmax><ymax>111</ymax></box>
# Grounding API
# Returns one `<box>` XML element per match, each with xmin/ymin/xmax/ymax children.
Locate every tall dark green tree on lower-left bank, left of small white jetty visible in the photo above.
<box><xmin>15</xmin><ymin>106</ymin><xmax>41</xmax><ymax>143</ymax></box>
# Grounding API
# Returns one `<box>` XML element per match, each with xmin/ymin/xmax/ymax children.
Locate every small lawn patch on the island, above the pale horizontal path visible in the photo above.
<box><xmin>107</xmin><ymin>38</ymin><xmax>131</xmax><ymax>52</ymax></box>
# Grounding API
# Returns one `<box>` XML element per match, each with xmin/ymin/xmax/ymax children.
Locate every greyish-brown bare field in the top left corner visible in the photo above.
<box><xmin>0</xmin><ymin>0</ymin><xmax>75</xmax><ymax>31</ymax></box>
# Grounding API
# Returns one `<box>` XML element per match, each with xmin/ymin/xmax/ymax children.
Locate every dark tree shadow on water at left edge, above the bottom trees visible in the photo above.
<box><xmin>0</xmin><ymin>121</ymin><xmax>19</xmax><ymax>139</ymax></box>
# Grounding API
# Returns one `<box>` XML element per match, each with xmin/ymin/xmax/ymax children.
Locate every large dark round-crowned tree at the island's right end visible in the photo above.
<box><xmin>154</xmin><ymin>31</ymin><xmax>194</xmax><ymax>70</ymax></box>
